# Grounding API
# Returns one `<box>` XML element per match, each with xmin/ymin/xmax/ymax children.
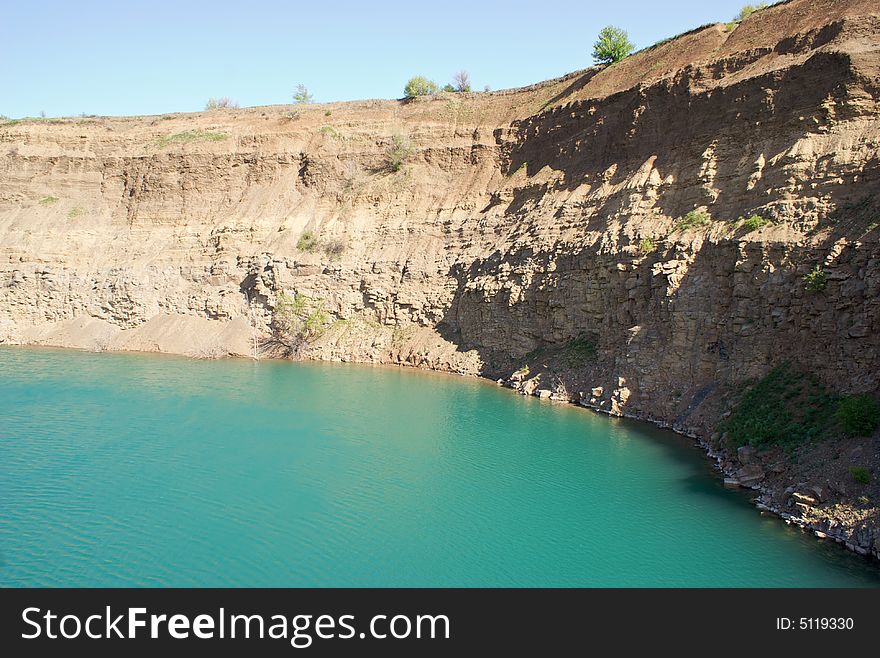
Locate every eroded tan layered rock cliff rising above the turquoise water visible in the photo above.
<box><xmin>0</xmin><ymin>0</ymin><xmax>880</xmax><ymax>554</ymax></box>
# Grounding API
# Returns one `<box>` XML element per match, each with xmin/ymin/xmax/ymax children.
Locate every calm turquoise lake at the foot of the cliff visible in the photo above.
<box><xmin>0</xmin><ymin>348</ymin><xmax>880</xmax><ymax>587</ymax></box>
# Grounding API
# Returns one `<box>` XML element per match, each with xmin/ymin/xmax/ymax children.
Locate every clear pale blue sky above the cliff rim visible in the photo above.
<box><xmin>0</xmin><ymin>0</ymin><xmax>744</xmax><ymax>117</ymax></box>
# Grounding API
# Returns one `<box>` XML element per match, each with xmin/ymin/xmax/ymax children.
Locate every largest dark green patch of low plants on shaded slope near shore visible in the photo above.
<box><xmin>720</xmin><ymin>364</ymin><xmax>836</xmax><ymax>449</ymax></box>
